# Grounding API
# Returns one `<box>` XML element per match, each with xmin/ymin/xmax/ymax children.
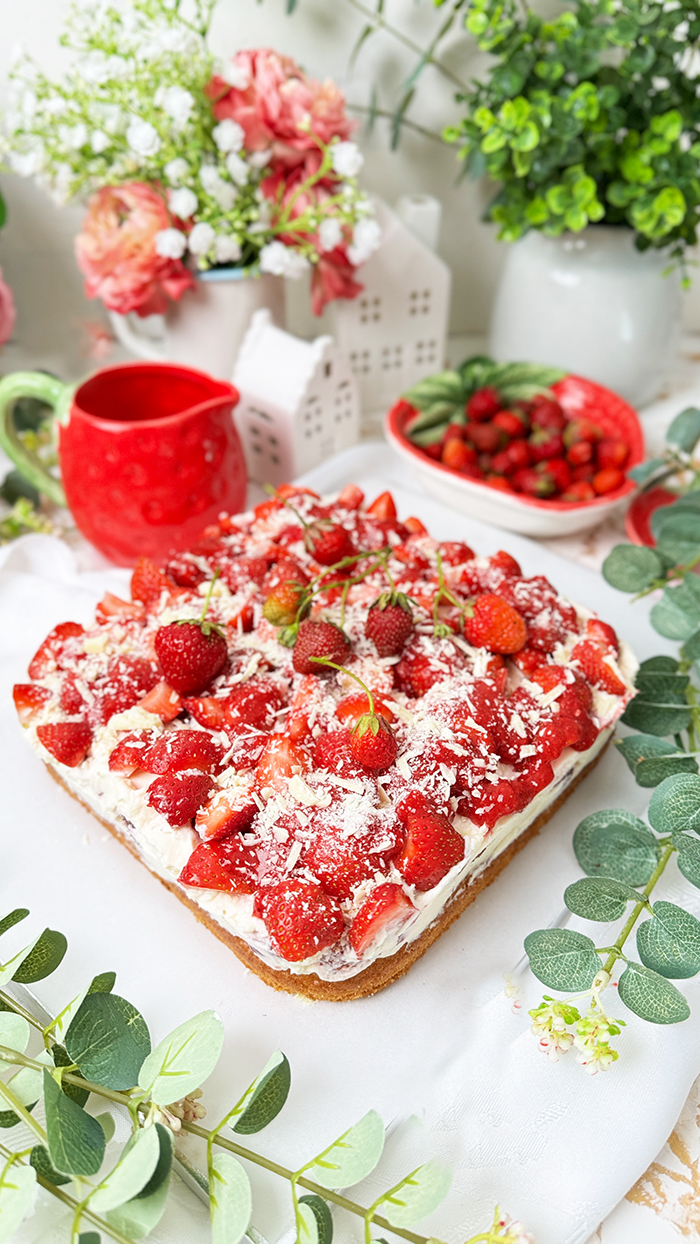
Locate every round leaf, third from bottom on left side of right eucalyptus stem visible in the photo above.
<box><xmin>573</xmin><ymin>807</ymin><xmax>659</xmax><ymax>887</ymax></box>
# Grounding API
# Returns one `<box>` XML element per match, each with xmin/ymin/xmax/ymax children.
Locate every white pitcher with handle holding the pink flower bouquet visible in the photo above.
<box><xmin>109</xmin><ymin>267</ymin><xmax>285</xmax><ymax>381</ymax></box>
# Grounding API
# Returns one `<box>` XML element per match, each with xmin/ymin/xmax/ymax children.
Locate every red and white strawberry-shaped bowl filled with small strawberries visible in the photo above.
<box><xmin>387</xmin><ymin>356</ymin><xmax>644</xmax><ymax>536</ymax></box>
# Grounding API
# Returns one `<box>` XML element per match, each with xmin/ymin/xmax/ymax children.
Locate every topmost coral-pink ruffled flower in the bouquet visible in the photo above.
<box><xmin>206</xmin><ymin>47</ymin><xmax>354</xmax><ymax>165</ymax></box>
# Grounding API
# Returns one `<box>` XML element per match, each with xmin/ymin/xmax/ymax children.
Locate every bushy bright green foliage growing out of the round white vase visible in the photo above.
<box><xmin>446</xmin><ymin>0</ymin><xmax>700</xmax><ymax>267</ymax></box>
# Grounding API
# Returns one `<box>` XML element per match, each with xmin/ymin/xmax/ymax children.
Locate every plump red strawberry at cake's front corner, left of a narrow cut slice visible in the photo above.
<box><xmin>261</xmin><ymin>877</ymin><xmax>344</xmax><ymax>963</ymax></box>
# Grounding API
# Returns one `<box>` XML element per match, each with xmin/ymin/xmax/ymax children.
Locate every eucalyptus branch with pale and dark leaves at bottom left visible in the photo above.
<box><xmin>0</xmin><ymin>905</ymin><xmax>529</xmax><ymax>1244</ymax></box>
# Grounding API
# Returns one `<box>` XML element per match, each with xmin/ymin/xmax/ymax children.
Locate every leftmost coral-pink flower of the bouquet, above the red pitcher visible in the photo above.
<box><xmin>76</xmin><ymin>182</ymin><xmax>194</xmax><ymax>316</ymax></box>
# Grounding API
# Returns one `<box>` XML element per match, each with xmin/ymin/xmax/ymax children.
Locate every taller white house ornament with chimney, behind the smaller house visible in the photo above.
<box><xmin>325</xmin><ymin>202</ymin><xmax>451</xmax><ymax>414</ymax></box>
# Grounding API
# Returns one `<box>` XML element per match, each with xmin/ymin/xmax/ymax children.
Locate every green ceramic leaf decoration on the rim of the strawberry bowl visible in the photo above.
<box><xmin>403</xmin><ymin>355</ymin><xmax>566</xmax><ymax>449</ymax></box>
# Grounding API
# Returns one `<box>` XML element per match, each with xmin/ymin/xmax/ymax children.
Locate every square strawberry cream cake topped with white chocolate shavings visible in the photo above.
<box><xmin>14</xmin><ymin>485</ymin><xmax>637</xmax><ymax>999</ymax></box>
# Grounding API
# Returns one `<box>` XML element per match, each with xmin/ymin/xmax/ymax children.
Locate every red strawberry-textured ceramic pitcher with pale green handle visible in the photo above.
<box><xmin>0</xmin><ymin>362</ymin><xmax>246</xmax><ymax>565</ymax></box>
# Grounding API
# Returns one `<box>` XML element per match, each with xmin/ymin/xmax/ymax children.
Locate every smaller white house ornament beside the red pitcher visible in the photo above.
<box><xmin>233</xmin><ymin>309</ymin><xmax>359</xmax><ymax>486</ymax></box>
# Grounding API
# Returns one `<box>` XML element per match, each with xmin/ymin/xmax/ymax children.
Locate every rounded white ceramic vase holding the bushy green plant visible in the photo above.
<box><xmin>490</xmin><ymin>225</ymin><xmax>680</xmax><ymax>406</ymax></box>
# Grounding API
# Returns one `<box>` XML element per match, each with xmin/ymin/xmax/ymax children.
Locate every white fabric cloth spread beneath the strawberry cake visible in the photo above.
<box><xmin>0</xmin><ymin>495</ymin><xmax>700</xmax><ymax>1244</ymax></box>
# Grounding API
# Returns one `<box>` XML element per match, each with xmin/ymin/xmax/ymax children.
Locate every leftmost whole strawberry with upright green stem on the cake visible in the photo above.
<box><xmin>154</xmin><ymin>571</ymin><xmax>229</xmax><ymax>695</ymax></box>
